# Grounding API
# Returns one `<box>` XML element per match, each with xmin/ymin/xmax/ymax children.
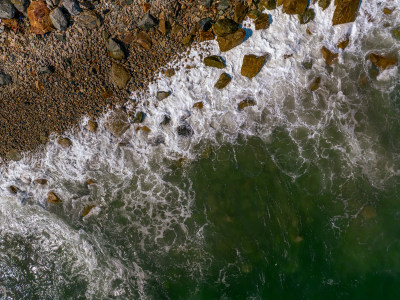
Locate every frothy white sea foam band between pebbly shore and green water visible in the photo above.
<box><xmin>0</xmin><ymin>0</ymin><xmax>400</xmax><ymax>297</ymax></box>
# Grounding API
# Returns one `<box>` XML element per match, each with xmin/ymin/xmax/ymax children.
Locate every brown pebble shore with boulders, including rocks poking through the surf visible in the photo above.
<box><xmin>0</xmin><ymin>0</ymin><xmax>397</xmax><ymax>160</ymax></box>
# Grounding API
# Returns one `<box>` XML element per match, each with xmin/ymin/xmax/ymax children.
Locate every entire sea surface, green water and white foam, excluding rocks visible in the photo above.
<box><xmin>0</xmin><ymin>0</ymin><xmax>400</xmax><ymax>300</ymax></box>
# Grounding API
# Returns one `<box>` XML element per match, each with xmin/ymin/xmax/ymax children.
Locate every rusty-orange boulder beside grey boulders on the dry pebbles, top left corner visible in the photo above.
<box><xmin>27</xmin><ymin>1</ymin><xmax>53</xmax><ymax>34</ymax></box>
